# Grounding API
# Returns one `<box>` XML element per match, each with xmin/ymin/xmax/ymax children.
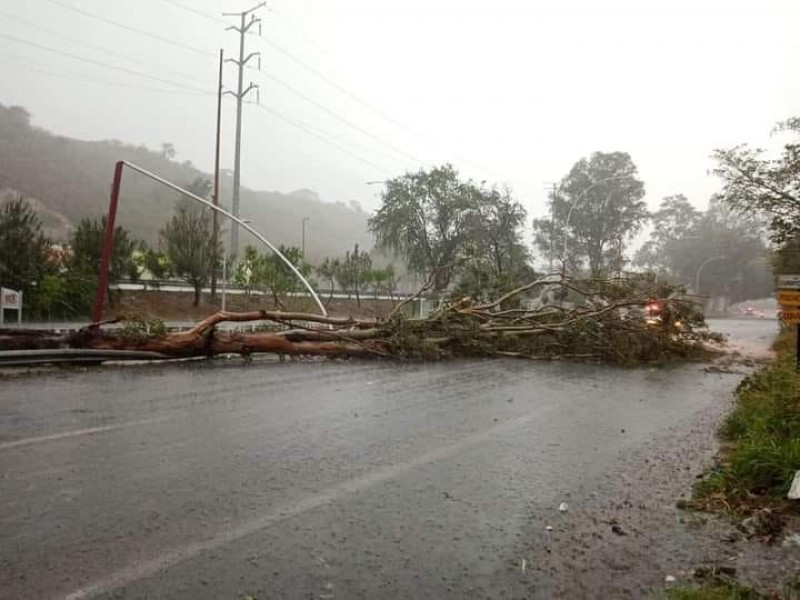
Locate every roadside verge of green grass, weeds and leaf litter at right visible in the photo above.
<box><xmin>666</xmin><ymin>329</ymin><xmax>800</xmax><ymax>600</ymax></box>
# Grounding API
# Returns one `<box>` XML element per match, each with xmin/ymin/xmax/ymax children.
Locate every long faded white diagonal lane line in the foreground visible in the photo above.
<box><xmin>64</xmin><ymin>403</ymin><xmax>558</xmax><ymax>600</ymax></box>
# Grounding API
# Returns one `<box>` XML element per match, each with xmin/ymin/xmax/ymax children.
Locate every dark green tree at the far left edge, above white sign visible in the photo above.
<box><xmin>0</xmin><ymin>196</ymin><xmax>49</xmax><ymax>306</ymax></box>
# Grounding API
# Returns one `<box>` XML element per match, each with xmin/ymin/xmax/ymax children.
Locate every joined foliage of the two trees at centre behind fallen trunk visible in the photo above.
<box><xmin>370</xmin><ymin>165</ymin><xmax>531</xmax><ymax>297</ymax></box>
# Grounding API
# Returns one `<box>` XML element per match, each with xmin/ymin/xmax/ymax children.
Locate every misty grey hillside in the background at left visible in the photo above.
<box><xmin>0</xmin><ymin>104</ymin><xmax>373</xmax><ymax>262</ymax></box>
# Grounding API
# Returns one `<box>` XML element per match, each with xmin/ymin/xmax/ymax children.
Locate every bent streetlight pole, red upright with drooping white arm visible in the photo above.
<box><xmin>92</xmin><ymin>160</ymin><xmax>328</xmax><ymax>325</ymax></box>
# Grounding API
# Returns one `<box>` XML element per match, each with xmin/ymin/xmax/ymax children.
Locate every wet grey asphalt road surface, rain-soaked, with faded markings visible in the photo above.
<box><xmin>0</xmin><ymin>320</ymin><xmax>776</xmax><ymax>600</ymax></box>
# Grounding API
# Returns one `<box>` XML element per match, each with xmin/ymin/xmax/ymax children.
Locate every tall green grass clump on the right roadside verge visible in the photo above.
<box><xmin>695</xmin><ymin>331</ymin><xmax>800</xmax><ymax>508</ymax></box>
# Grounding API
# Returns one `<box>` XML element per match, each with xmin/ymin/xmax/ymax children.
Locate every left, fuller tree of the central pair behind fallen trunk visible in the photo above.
<box><xmin>369</xmin><ymin>165</ymin><xmax>477</xmax><ymax>292</ymax></box>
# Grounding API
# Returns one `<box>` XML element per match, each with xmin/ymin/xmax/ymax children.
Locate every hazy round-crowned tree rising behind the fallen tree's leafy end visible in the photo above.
<box><xmin>533</xmin><ymin>152</ymin><xmax>649</xmax><ymax>273</ymax></box>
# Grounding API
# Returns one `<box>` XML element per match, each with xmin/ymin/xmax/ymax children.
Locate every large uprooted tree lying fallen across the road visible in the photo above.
<box><xmin>0</xmin><ymin>278</ymin><xmax>720</xmax><ymax>363</ymax></box>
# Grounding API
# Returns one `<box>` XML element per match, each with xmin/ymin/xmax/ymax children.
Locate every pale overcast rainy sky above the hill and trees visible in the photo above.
<box><xmin>0</xmin><ymin>0</ymin><xmax>800</xmax><ymax>220</ymax></box>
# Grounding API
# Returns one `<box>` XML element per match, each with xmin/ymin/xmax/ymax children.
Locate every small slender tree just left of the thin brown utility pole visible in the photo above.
<box><xmin>161</xmin><ymin>202</ymin><xmax>222</xmax><ymax>306</ymax></box>
